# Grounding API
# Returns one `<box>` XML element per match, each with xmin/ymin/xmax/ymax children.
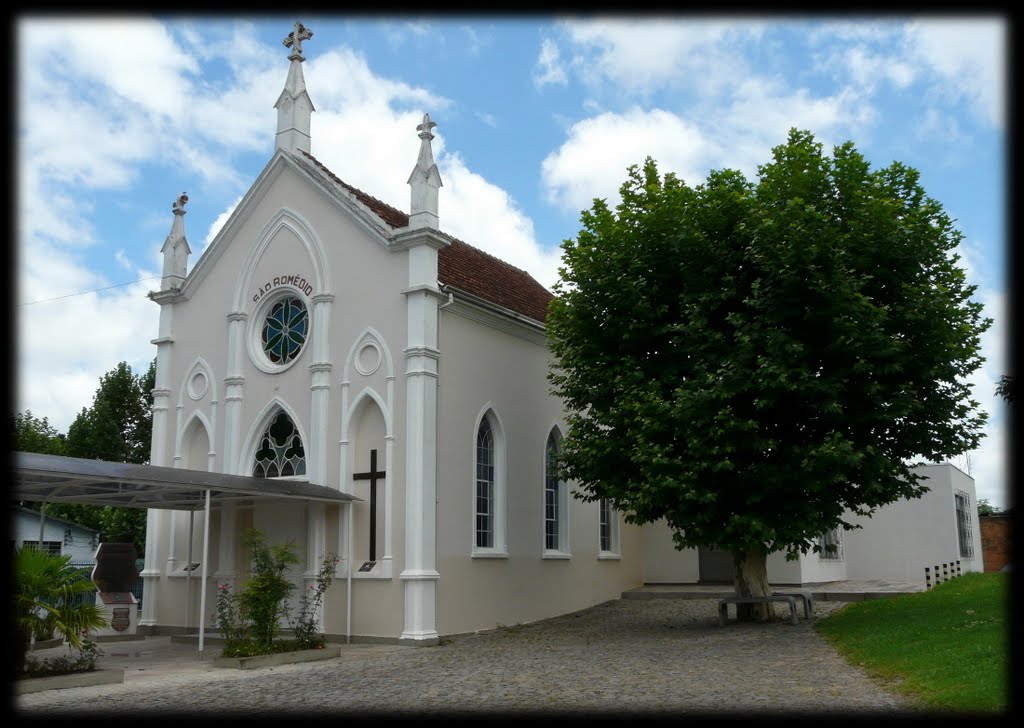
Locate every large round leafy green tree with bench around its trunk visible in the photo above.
<box><xmin>548</xmin><ymin>130</ymin><xmax>991</xmax><ymax>620</ymax></box>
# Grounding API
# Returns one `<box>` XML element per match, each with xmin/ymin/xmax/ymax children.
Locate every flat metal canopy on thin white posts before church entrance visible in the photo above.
<box><xmin>8</xmin><ymin>453</ymin><xmax>362</xmax><ymax>655</ymax></box>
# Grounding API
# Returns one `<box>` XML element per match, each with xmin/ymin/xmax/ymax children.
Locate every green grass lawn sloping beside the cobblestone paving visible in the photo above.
<box><xmin>816</xmin><ymin>572</ymin><xmax>1011</xmax><ymax>714</ymax></box>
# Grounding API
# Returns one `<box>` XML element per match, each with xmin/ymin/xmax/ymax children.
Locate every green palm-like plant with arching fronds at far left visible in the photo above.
<box><xmin>13</xmin><ymin>547</ymin><xmax>108</xmax><ymax>665</ymax></box>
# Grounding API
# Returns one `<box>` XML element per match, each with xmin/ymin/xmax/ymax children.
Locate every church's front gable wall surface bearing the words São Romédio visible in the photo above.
<box><xmin>147</xmin><ymin>161</ymin><xmax>408</xmax><ymax>635</ymax></box>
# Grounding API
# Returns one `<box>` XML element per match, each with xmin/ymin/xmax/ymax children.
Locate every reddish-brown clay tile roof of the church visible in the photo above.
<box><xmin>302</xmin><ymin>152</ymin><xmax>554</xmax><ymax>324</ymax></box>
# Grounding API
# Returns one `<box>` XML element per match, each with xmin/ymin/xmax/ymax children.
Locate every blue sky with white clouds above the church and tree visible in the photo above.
<box><xmin>16</xmin><ymin>13</ymin><xmax>1011</xmax><ymax>506</ymax></box>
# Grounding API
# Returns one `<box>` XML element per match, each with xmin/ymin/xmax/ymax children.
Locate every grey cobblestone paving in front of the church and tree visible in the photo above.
<box><xmin>13</xmin><ymin>598</ymin><xmax>926</xmax><ymax>720</ymax></box>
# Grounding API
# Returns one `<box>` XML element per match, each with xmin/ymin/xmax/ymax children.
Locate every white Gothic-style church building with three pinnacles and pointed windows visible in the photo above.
<box><xmin>139</xmin><ymin>24</ymin><xmax>982</xmax><ymax>644</ymax></box>
